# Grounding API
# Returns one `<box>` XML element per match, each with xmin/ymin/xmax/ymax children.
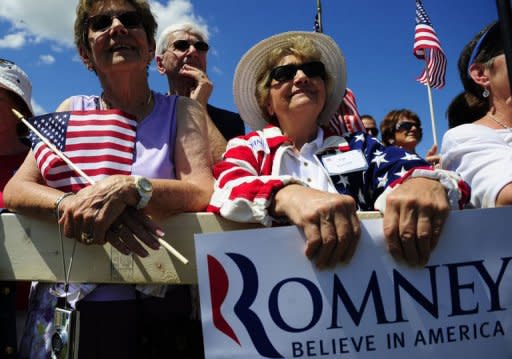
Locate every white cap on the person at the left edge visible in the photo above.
<box><xmin>0</xmin><ymin>59</ymin><xmax>34</xmax><ymax>114</ymax></box>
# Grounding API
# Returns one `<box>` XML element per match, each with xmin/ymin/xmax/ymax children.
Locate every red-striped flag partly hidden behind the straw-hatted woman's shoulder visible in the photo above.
<box><xmin>324</xmin><ymin>88</ymin><xmax>366</xmax><ymax>136</ymax></box>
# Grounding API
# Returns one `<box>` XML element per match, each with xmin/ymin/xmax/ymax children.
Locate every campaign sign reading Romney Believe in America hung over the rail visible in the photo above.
<box><xmin>195</xmin><ymin>207</ymin><xmax>512</xmax><ymax>359</ymax></box>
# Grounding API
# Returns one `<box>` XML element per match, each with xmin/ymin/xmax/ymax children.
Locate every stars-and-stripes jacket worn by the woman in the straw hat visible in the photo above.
<box><xmin>208</xmin><ymin>125</ymin><xmax>466</xmax><ymax>226</ymax></box>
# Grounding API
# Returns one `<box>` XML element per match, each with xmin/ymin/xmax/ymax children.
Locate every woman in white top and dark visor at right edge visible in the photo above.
<box><xmin>441</xmin><ymin>23</ymin><xmax>512</xmax><ymax>208</ymax></box>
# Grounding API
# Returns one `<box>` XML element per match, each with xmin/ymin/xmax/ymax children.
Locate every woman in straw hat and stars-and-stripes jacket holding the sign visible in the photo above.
<box><xmin>209</xmin><ymin>32</ymin><xmax>468</xmax><ymax>268</ymax></box>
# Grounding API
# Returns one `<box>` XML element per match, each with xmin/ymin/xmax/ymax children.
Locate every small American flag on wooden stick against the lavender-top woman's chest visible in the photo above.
<box><xmin>29</xmin><ymin>110</ymin><xmax>137</xmax><ymax>192</ymax></box>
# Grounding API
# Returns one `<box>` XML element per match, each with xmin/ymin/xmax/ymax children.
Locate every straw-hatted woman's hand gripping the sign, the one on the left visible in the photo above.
<box><xmin>274</xmin><ymin>185</ymin><xmax>361</xmax><ymax>268</ymax></box>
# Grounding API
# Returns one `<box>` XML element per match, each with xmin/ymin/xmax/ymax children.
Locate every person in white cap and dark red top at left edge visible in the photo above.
<box><xmin>0</xmin><ymin>59</ymin><xmax>33</xmax><ymax>358</ymax></box>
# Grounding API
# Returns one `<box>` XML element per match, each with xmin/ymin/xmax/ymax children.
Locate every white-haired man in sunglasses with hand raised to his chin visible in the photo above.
<box><xmin>156</xmin><ymin>23</ymin><xmax>245</xmax><ymax>146</ymax></box>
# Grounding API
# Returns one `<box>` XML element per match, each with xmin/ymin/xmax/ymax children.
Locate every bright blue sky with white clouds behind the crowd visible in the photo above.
<box><xmin>0</xmin><ymin>0</ymin><xmax>497</xmax><ymax>154</ymax></box>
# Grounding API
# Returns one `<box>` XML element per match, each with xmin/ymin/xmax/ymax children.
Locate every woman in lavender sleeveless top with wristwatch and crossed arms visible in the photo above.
<box><xmin>5</xmin><ymin>0</ymin><xmax>213</xmax><ymax>358</ymax></box>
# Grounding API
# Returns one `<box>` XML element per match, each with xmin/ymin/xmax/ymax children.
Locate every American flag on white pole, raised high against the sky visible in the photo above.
<box><xmin>414</xmin><ymin>0</ymin><xmax>446</xmax><ymax>88</ymax></box>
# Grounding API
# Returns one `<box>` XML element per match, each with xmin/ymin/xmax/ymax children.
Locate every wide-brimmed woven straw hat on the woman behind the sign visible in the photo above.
<box><xmin>233</xmin><ymin>31</ymin><xmax>347</xmax><ymax>131</ymax></box>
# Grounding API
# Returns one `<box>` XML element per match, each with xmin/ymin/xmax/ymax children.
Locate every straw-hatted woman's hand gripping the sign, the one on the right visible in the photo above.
<box><xmin>384</xmin><ymin>178</ymin><xmax>450</xmax><ymax>266</ymax></box>
